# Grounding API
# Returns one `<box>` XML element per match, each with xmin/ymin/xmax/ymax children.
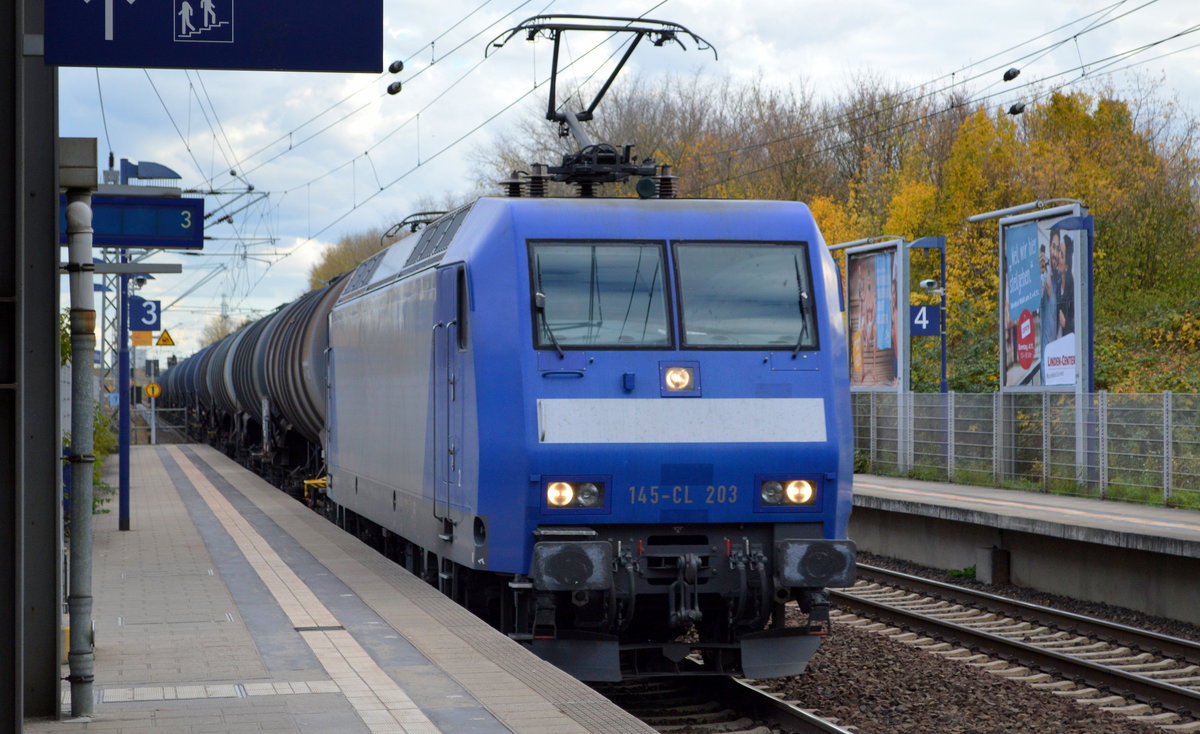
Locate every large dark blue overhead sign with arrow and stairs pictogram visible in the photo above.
<box><xmin>46</xmin><ymin>0</ymin><xmax>383</xmax><ymax>72</ymax></box>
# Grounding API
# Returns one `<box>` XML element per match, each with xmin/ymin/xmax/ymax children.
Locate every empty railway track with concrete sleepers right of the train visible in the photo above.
<box><xmin>832</xmin><ymin>565</ymin><xmax>1200</xmax><ymax>730</ymax></box>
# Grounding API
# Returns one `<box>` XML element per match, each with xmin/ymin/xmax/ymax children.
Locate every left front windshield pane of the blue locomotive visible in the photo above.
<box><xmin>529</xmin><ymin>237</ymin><xmax>672</xmax><ymax>349</ymax></box>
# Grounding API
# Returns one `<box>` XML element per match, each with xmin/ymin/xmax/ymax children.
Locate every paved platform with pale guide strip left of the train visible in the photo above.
<box><xmin>25</xmin><ymin>445</ymin><xmax>653</xmax><ymax>734</ymax></box>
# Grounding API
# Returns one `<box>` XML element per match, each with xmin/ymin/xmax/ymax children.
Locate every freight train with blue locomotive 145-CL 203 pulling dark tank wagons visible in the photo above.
<box><xmin>164</xmin><ymin>198</ymin><xmax>854</xmax><ymax>680</ymax></box>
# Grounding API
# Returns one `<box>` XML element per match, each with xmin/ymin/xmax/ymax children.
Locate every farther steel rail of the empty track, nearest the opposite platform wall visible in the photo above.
<box><xmin>858</xmin><ymin>564</ymin><xmax>1200</xmax><ymax>664</ymax></box>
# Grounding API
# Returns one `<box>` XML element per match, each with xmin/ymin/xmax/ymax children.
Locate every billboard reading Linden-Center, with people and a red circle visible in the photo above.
<box><xmin>1000</xmin><ymin>207</ymin><xmax>1092</xmax><ymax>390</ymax></box>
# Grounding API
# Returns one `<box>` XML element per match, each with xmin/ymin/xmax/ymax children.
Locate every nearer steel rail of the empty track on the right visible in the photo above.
<box><xmin>830</xmin><ymin>582</ymin><xmax>1200</xmax><ymax>718</ymax></box>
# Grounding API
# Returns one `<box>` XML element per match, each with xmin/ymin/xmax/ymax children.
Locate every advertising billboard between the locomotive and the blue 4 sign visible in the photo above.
<box><xmin>846</xmin><ymin>241</ymin><xmax>908</xmax><ymax>390</ymax></box>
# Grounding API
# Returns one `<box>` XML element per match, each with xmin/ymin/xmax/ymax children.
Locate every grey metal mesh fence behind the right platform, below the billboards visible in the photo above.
<box><xmin>852</xmin><ymin>392</ymin><xmax>1200</xmax><ymax>509</ymax></box>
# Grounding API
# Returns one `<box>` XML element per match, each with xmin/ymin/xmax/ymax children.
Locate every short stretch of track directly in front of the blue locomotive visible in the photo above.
<box><xmin>593</xmin><ymin>676</ymin><xmax>853</xmax><ymax>734</ymax></box>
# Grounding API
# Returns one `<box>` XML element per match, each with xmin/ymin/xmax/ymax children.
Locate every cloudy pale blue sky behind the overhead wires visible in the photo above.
<box><xmin>59</xmin><ymin>0</ymin><xmax>1200</xmax><ymax>356</ymax></box>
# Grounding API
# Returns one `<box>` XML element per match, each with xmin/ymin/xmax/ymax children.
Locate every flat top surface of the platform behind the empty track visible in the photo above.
<box><xmin>854</xmin><ymin>474</ymin><xmax>1200</xmax><ymax>558</ymax></box>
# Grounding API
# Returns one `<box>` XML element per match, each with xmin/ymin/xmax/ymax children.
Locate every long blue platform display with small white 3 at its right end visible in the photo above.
<box><xmin>59</xmin><ymin>194</ymin><xmax>204</xmax><ymax>249</ymax></box>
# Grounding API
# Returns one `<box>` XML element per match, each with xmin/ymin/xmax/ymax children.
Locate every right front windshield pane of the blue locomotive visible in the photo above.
<box><xmin>674</xmin><ymin>242</ymin><xmax>817</xmax><ymax>350</ymax></box>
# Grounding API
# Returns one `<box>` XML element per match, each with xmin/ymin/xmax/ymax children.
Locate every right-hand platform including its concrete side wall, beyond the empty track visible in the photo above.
<box><xmin>848</xmin><ymin>474</ymin><xmax>1200</xmax><ymax>624</ymax></box>
